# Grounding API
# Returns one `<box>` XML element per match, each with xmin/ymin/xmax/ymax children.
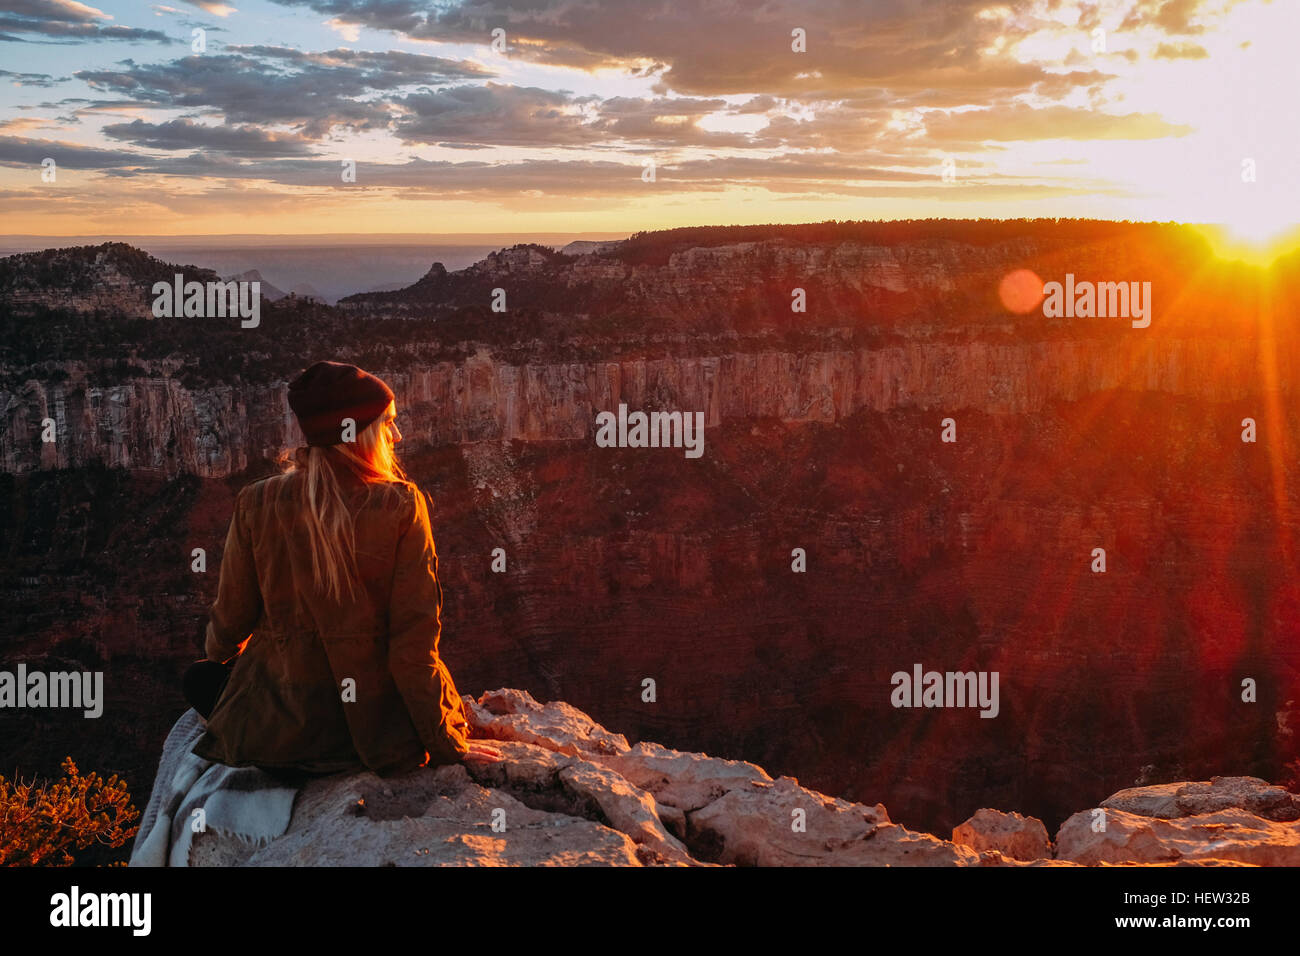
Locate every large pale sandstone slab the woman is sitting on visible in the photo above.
<box><xmin>178</xmin><ymin>688</ymin><xmax>982</xmax><ymax>866</ymax></box>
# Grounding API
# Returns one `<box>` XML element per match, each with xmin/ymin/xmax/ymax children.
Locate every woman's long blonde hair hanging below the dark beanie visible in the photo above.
<box><xmin>271</xmin><ymin>402</ymin><xmax>415</xmax><ymax>602</ymax></box>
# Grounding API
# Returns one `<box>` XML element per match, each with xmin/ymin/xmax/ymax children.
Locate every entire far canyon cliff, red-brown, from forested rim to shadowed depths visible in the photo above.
<box><xmin>0</xmin><ymin>222</ymin><xmax>1300</xmax><ymax>831</ymax></box>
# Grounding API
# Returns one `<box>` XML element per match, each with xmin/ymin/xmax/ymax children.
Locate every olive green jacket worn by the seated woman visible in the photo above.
<box><xmin>194</xmin><ymin>472</ymin><xmax>469</xmax><ymax>775</ymax></box>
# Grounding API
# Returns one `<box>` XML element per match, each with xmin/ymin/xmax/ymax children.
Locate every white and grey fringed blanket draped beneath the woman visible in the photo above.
<box><xmin>127</xmin><ymin>708</ymin><xmax>298</xmax><ymax>866</ymax></box>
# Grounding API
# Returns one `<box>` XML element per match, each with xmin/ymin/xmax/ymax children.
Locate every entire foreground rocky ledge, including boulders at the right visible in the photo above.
<box><xmin>190</xmin><ymin>689</ymin><xmax>1300</xmax><ymax>866</ymax></box>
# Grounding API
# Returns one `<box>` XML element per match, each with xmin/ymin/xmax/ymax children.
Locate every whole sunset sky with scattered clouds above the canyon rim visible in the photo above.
<box><xmin>0</xmin><ymin>0</ymin><xmax>1300</xmax><ymax>238</ymax></box>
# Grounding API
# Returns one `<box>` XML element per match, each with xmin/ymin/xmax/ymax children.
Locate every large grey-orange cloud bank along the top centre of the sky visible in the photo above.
<box><xmin>263</xmin><ymin>0</ymin><xmax>1066</xmax><ymax>103</ymax></box>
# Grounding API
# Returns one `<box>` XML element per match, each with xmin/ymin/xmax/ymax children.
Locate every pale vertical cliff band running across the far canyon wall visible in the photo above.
<box><xmin>0</xmin><ymin>337</ymin><xmax>1297</xmax><ymax>477</ymax></box>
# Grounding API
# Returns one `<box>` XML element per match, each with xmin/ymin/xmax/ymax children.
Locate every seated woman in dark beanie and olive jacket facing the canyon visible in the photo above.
<box><xmin>185</xmin><ymin>362</ymin><xmax>502</xmax><ymax>777</ymax></box>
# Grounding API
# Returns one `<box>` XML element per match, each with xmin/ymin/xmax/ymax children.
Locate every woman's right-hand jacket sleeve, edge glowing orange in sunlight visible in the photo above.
<box><xmin>389</xmin><ymin>489</ymin><xmax>469</xmax><ymax>765</ymax></box>
